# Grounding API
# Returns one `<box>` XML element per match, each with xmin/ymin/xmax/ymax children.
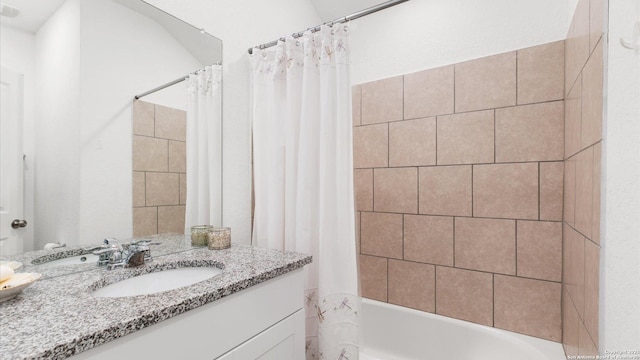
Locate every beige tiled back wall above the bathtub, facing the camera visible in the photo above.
<box><xmin>353</xmin><ymin>41</ymin><xmax>564</xmax><ymax>341</ymax></box>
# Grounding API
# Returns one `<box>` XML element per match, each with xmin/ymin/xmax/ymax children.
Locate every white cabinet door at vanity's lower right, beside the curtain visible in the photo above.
<box><xmin>224</xmin><ymin>310</ymin><xmax>304</xmax><ymax>360</ymax></box>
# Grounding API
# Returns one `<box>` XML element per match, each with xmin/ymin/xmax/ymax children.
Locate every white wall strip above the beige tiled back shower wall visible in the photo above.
<box><xmin>351</xmin><ymin>0</ymin><xmax>575</xmax><ymax>84</ymax></box>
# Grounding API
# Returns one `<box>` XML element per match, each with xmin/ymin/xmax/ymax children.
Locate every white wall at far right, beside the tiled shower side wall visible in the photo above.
<box><xmin>599</xmin><ymin>0</ymin><xmax>640</xmax><ymax>355</ymax></box>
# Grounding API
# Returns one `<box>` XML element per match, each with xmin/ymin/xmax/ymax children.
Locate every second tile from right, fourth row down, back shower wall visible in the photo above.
<box><xmin>454</xmin><ymin>218</ymin><xmax>516</xmax><ymax>275</ymax></box>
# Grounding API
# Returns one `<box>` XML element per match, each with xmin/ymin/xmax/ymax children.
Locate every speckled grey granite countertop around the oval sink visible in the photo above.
<box><xmin>0</xmin><ymin>240</ymin><xmax>311</xmax><ymax>359</ymax></box>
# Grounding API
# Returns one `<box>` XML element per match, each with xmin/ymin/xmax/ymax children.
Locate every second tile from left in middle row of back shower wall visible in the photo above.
<box><xmin>373</xmin><ymin>167</ymin><xmax>418</xmax><ymax>214</ymax></box>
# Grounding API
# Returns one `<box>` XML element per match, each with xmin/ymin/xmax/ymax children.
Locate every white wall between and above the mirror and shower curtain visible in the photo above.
<box><xmin>148</xmin><ymin>0</ymin><xmax>320</xmax><ymax>243</ymax></box>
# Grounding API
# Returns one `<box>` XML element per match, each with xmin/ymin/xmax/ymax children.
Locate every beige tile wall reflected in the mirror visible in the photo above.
<box><xmin>133</xmin><ymin>100</ymin><xmax>187</xmax><ymax>236</ymax></box>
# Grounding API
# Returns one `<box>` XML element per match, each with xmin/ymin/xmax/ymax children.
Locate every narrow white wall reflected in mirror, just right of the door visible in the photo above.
<box><xmin>33</xmin><ymin>0</ymin><xmax>80</xmax><ymax>249</ymax></box>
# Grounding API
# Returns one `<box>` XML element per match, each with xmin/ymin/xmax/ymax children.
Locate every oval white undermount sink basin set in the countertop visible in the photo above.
<box><xmin>92</xmin><ymin>267</ymin><xmax>222</xmax><ymax>297</ymax></box>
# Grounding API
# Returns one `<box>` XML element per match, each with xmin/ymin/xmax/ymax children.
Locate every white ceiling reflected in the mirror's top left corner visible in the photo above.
<box><xmin>0</xmin><ymin>0</ymin><xmax>65</xmax><ymax>33</ymax></box>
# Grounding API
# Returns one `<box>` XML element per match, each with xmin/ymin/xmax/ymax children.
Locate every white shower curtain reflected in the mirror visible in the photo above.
<box><xmin>185</xmin><ymin>65</ymin><xmax>222</xmax><ymax>229</ymax></box>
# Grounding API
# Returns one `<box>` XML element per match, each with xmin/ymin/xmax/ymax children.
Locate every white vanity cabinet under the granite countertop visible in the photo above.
<box><xmin>73</xmin><ymin>268</ymin><xmax>305</xmax><ymax>360</ymax></box>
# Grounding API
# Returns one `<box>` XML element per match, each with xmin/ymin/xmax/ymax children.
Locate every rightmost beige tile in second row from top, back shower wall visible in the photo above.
<box><xmin>496</xmin><ymin>101</ymin><xmax>564</xmax><ymax>162</ymax></box>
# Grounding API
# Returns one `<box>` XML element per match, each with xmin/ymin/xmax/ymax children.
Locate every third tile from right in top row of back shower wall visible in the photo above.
<box><xmin>404</xmin><ymin>65</ymin><xmax>453</xmax><ymax>119</ymax></box>
